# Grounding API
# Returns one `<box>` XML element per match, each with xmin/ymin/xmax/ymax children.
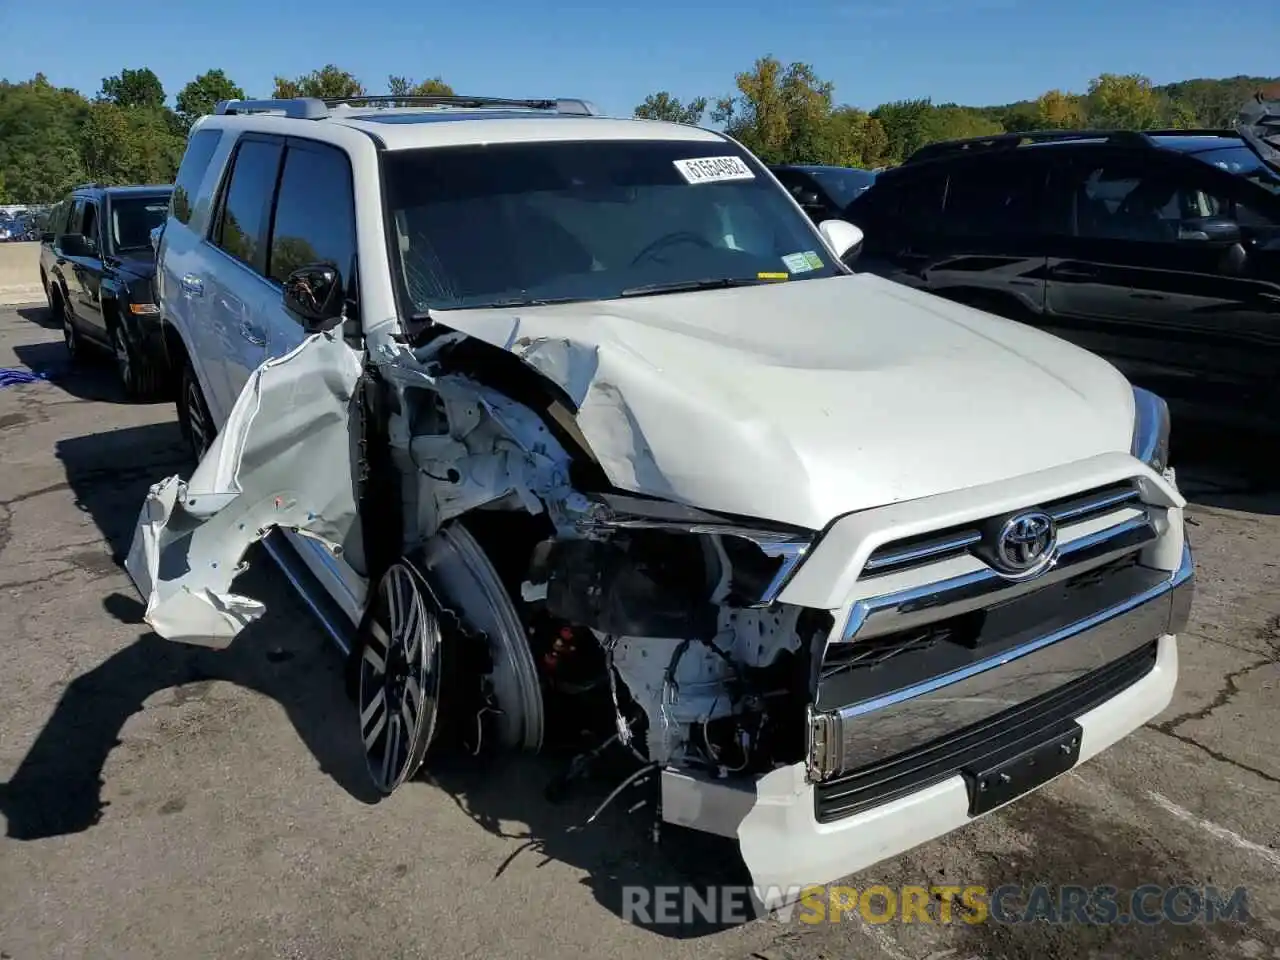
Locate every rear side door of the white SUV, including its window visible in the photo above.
<box><xmin>204</xmin><ymin>133</ymin><xmax>284</xmax><ymax>421</ymax></box>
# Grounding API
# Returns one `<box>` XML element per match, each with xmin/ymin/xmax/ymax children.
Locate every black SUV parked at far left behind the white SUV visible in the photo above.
<box><xmin>40</xmin><ymin>184</ymin><xmax>173</xmax><ymax>399</ymax></box>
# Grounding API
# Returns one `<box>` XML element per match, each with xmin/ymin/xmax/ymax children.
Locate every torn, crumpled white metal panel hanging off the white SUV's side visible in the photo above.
<box><xmin>125</xmin><ymin>334</ymin><xmax>361</xmax><ymax>646</ymax></box>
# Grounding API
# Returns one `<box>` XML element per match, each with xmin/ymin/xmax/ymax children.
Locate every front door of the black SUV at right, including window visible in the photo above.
<box><xmin>1047</xmin><ymin>150</ymin><xmax>1280</xmax><ymax>410</ymax></box>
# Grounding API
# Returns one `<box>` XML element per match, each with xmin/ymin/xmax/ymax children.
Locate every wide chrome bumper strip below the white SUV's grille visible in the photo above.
<box><xmin>808</xmin><ymin>545</ymin><xmax>1194</xmax><ymax>781</ymax></box>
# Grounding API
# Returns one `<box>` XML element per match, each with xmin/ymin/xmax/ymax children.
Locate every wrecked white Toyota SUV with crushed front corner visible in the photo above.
<box><xmin>128</xmin><ymin>97</ymin><xmax>1193</xmax><ymax>891</ymax></box>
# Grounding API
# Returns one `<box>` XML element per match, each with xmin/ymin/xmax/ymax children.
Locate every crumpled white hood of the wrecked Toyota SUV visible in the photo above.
<box><xmin>433</xmin><ymin>274</ymin><xmax>1134</xmax><ymax>529</ymax></box>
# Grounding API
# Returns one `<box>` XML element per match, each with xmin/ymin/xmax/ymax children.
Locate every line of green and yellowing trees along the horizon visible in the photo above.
<box><xmin>0</xmin><ymin>56</ymin><xmax>1280</xmax><ymax>204</ymax></box>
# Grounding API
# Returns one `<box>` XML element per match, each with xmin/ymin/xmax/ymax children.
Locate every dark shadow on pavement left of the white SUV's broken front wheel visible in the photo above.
<box><xmin>0</xmin><ymin>424</ymin><xmax>376</xmax><ymax>840</ymax></box>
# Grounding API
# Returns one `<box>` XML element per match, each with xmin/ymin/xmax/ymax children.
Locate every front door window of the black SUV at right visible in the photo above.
<box><xmin>1075</xmin><ymin>161</ymin><xmax>1231</xmax><ymax>243</ymax></box>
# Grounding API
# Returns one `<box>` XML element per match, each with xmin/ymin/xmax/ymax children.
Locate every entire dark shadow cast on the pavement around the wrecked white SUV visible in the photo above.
<box><xmin>0</xmin><ymin>424</ymin><xmax>754</xmax><ymax>938</ymax></box>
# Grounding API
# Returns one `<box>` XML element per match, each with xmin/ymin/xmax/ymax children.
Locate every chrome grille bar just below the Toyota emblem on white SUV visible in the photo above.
<box><xmin>833</xmin><ymin>516</ymin><xmax>1156</xmax><ymax>643</ymax></box>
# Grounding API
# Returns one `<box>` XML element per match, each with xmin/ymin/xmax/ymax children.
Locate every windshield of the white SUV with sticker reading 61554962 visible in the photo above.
<box><xmin>384</xmin><ymin>141</ymin><xmax>844</xmax><ymax>314</ymax></box>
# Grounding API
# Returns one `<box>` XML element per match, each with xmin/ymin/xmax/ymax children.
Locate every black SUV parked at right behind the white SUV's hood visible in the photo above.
<box><xmin>845</xmin><ymin>119</ymin><xmax>1280</xmax><ymax>431</ymax></box>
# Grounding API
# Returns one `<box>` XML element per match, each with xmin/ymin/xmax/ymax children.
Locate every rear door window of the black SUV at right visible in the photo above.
<box><xmin>941</xmin><ymin>157</ymin><xmax>1044</xmax><ymax>237</ymax></box>
